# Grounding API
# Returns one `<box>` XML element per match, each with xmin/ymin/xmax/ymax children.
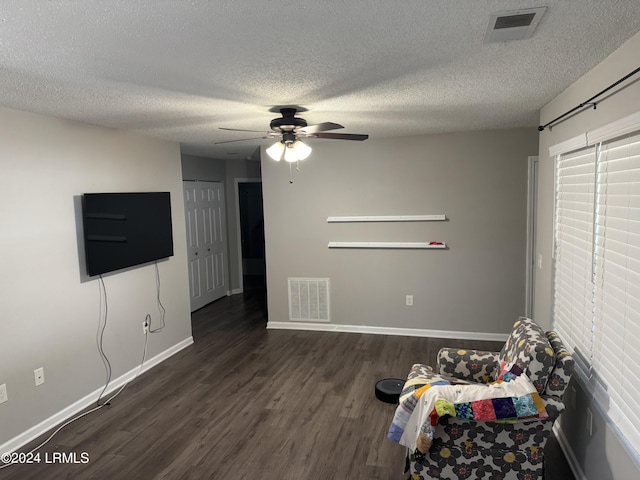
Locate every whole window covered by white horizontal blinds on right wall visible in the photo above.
<box><xmin>554</xmin><ymin>115</ymin><xmax>640</xmax><ymax>460</ymax></box>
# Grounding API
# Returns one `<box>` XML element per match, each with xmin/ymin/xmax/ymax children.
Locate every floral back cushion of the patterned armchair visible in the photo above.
<box><xmin>499</xmin><ymin>317</ymin><xmax>556</xmax><ymax>393</ymax></box>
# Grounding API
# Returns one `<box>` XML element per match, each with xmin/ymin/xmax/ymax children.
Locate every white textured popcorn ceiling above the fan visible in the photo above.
<box><xmin>0</xmin><ymin>0</ymin><xmax>640</xmax><ymax>158</ymax></box>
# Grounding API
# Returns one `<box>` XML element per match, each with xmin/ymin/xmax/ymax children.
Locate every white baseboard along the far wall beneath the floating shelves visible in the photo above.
<box><xmin>267</xmin><ymin>322</ymin><xmax>509</xmax><ymax>342</ymax></box>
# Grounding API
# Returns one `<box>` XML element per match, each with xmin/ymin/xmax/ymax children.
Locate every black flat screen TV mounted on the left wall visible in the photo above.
<box><xmin>82</xmin><ymin>192</ymin><xmax>173</xmax><ymax>276</ymax></box>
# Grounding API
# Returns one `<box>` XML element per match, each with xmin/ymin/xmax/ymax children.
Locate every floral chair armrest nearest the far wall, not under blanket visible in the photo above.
<box><xmin>436</xmin><ymin>348</ymin><xmax>499</xmax><ymax>383</ymax></box>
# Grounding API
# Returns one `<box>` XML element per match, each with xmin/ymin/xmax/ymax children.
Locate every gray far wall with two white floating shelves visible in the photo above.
<box><xmin>262</xmin><ymin>129</ymin><xmax>538</xmax><ymax>334</ymax></box>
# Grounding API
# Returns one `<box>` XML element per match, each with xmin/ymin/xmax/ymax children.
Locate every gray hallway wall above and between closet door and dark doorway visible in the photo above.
<box><xmin>182</xmin><ymin>153</ymin><xmax>262</xmax><ymax>293</ymax></box>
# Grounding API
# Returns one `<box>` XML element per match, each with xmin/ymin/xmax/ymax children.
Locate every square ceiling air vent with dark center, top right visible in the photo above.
<box><xmin>484</xmin><ymin>7</ymin><xmax>547</xmax><ymax>43</ymax></box>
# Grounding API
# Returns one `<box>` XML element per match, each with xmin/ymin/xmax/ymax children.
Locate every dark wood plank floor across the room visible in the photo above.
<box><xmin>0</xmin><ymin>290</ymin><xmax>573</xmax><ymax>480</ymax></box>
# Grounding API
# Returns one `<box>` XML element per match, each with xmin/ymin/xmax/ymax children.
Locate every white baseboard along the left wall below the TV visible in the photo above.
<box><xmin>0</xmin><ymin>337</ymin><xmax>193</xmax><ymax>454</ymax></box>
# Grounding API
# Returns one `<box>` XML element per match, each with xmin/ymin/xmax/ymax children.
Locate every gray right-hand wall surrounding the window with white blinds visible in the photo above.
<box><xmin>533</xmin><ymin>29</ymin><xmax>640</xmax><ymax>480</ymax></box>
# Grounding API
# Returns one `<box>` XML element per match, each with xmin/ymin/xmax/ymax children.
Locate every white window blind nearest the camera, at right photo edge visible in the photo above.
<box><xmin>593</xmin><ymin>134</ymin><xmax>640</xmax><ymax>446</ymax></box>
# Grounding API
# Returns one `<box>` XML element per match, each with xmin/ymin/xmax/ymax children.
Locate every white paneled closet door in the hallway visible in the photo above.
<box><xmin>184</xmin><ymin>181</ymin><xmax>228</xmax><ymax>312</ymax></box>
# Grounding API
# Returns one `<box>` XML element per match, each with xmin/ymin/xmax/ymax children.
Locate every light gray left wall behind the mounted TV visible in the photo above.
<box><xmin>0</xmin><ymin>109</ymin><xmax>191</xmax><ymax>446</ymax></box>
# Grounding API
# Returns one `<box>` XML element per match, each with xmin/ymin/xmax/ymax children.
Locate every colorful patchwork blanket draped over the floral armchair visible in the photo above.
<box><xmin>387</xmin><ymin>374</ymin><xmax>548</xmax><ymax>454</ymax></box>
